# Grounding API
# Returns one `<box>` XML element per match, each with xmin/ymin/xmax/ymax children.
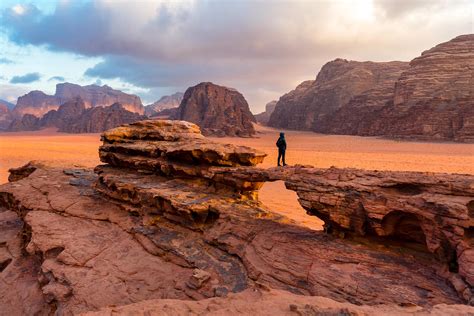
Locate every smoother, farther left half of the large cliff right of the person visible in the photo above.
<box><xmin>268</xmin><ymin>59</ymin><xmax>408</xmax><ymax>132</ymax></box>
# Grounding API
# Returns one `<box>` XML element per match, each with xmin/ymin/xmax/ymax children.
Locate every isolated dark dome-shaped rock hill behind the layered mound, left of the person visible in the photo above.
<box><xmin>175</xmin><ymin>82</ymin><xmax>256</xmax><ymax>137</ymax></box>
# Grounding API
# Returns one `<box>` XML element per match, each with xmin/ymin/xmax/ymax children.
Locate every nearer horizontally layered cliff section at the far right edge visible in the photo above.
<box><xmin>377</xmin><ymin>34</ymin><xmax>474</xmax><ymax>142</ymax></box>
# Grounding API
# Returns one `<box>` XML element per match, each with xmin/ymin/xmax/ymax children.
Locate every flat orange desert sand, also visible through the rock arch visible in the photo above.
<box><xmin>0</xmin><ymin>126</ymin><xmax>474</xmax><ymax>229</ymax></box>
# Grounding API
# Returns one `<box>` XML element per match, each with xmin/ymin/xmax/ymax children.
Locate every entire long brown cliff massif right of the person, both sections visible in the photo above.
<box><xmin>269</xmin><ymin>34</ymin><xmax>474</xmax><ymax>142</ymax></box>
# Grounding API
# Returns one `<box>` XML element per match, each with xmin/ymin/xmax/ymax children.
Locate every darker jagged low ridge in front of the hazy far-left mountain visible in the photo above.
<box><xmin>8</xmin><ymin>98</ymin><xmax>146</xmax><ymax>133</ymax></box>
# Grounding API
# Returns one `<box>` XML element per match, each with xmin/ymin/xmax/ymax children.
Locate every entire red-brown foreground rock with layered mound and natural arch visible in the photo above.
<box><xmin>0</xmin><ymin>121</ymin><xmax>474</xmax><ymax>315</ymax></box>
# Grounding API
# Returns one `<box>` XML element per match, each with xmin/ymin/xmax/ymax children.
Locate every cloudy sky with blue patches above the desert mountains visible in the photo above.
<box><xmin>0</xmin><ymin>0</ymin><xmax>474</xmax><ymax>113</ymax></box>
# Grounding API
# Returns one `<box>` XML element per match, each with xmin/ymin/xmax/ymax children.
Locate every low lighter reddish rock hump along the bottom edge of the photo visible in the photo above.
<box><xmin>84</xmin><ymin>287</ymin><xmax>473</xmax><ymax>316</ymax></box>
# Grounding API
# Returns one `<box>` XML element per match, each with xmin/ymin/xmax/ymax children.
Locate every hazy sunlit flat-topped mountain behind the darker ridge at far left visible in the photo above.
<box><xmin>12</xmin><ymin>83</ymin><xmax>144</xmax><ymax>118</ymax></box>
